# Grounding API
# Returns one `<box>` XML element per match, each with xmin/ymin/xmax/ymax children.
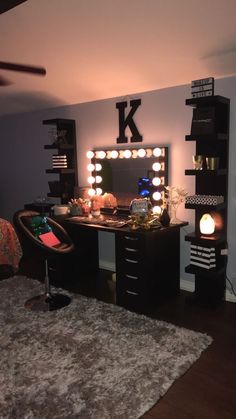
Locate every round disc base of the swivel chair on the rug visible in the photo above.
<box><xmin>25</xmin><ymin>294</ymin><xmax>71</xmax><ymax>311</ymax></box>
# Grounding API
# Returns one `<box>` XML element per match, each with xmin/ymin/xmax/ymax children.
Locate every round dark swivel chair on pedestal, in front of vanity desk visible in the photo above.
<box><xmin>13</xmin><ymin>209</ymin><xmax>74</xmax><ymax>311</ymax></box>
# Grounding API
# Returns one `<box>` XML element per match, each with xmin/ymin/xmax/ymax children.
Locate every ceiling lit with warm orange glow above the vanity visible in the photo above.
<box><xmin>0</xmin><ymin>0</ymin><xmax>236</xmax><ymax>115</ymax></box>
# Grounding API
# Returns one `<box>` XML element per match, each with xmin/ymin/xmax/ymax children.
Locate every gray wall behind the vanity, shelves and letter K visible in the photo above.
<box><xmin>0</xmin><ymin>77</ymin><xmax>236</xmax><ymax>287</ymax></box>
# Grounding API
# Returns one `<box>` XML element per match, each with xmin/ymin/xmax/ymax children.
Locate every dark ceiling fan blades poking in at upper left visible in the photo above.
<box><xmin>0</xmin><ymin>0</ymin><xmax>46</xmax><ymax>86</ymax></box>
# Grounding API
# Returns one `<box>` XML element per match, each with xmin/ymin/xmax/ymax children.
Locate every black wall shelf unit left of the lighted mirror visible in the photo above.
<box><xmin>43</xmin><ymin>118</ymin><xmax>78</xmax><ymax>204</ymax></box>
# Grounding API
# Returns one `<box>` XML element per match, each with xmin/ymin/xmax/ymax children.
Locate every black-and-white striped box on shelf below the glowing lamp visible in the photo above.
<box><xmin>190</xmin><ymin>244</ymin><xmax>216</xmax><ymax>269</ymax></box>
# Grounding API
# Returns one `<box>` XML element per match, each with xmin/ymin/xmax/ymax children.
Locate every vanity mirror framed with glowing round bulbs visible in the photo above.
<box><xmin>87</xmin><ymin>146</ymin><xmax>168</xmax><ymax>211</ymax></box>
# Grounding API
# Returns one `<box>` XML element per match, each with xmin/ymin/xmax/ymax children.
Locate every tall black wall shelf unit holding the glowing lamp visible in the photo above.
<box><xmin>185</xmin><ymin>95</ymin><xmax>230</xmax><ymax>306</ymax></box>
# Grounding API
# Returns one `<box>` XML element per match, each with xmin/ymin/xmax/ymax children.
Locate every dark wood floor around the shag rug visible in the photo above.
<box><xmin>4</xmin><ymin>262</ymin><xmax>236</xmax><ymax>419</ymax></box>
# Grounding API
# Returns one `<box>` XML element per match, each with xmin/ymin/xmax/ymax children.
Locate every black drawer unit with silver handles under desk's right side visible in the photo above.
<box><xmin>116</xmin><ymin>229</ymin><xmax>179</xmax><ymax>312</ymax></box>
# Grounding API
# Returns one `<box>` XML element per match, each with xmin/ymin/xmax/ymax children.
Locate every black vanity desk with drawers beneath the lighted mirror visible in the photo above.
<box><xmin>62</xmin><ymin>215</ymin><xmax>188</xmax><ymax>312</ymax></box>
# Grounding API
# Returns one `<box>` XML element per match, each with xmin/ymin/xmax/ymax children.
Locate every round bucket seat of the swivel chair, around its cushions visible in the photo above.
<box><xmin>13</xmin><ymin>209</ymin><xmax>74</xmax><ymax>258</ymax></box>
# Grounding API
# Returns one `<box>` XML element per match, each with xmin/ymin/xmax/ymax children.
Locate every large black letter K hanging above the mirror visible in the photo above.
<box><xmin>116</xmin><ymin>99</ymin><xmax>143</xmax><ymax>144</ymax></box>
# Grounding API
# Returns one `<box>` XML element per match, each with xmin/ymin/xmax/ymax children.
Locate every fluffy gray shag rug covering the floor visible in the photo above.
<box><xmin>0</xmin><ymin>276</ymin><xmax>212</xmax><ymax>419</ymax></box>
